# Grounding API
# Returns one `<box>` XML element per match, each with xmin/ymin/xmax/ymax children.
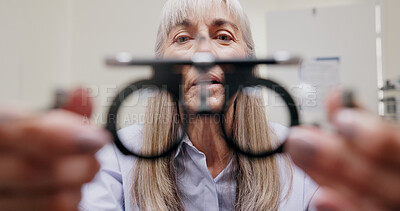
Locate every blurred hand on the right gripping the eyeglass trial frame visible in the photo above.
<box><xmin>286</xmin><ymin>91</ymin><xmax>400</xmax><ymax>211</ymax></box>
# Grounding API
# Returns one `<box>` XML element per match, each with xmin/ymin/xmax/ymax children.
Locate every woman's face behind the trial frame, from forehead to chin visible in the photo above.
<box><xmin>162</xmin><ymin>5</ymin><xmax>248</xmax><ymax>112</ymax></box>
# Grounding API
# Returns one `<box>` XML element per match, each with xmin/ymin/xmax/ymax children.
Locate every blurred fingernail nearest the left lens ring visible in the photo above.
<box><xmin>76</xmin><ymin>130</ymin><xmax>111</xmax><ymax>153</ymax></box>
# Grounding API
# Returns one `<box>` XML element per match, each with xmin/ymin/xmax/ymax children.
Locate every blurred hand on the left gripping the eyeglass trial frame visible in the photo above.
<box><xmin>0</xmin><ymin>90</ymin><xmax>111</xmax><ymax>210</ymax></box>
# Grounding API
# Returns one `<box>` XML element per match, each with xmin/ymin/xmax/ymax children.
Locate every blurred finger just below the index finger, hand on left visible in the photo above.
<box><xmin>0</xmin><ymin>155</ymin><xmax>99</xmax><ymax>192</ymax></box>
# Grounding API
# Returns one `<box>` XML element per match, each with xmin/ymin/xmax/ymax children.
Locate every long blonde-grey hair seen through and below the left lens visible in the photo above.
<box><xmin>131</xmin><ymin>92</ymin><xmax>183</xmax><ymax>211</ymax></box>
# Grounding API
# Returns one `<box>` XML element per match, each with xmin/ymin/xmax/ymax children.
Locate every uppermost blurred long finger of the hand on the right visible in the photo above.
<box><xmin>333</xmin><ymin>109</ymin><xmax>400</xmax><ymax>166</ymax></box>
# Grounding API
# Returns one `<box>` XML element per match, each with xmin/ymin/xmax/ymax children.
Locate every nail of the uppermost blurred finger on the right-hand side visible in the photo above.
<box><xmin>335</xmin><ymin>109</ymin><xmax>357</xmax><ymax>140</ymax></box>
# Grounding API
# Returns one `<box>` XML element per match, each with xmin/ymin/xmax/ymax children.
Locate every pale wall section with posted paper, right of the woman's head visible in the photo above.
<box><xmin>267</xmin><ymin>1</ymin><xmax>378</xmax><ymax>127</ymax></box>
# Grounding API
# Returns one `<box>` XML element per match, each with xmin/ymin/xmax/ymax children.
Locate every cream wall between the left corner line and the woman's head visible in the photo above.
<box><xmin>71</xmin><ymin>0</ymin><xmax>162</xmax><ymax>122</ymax></box>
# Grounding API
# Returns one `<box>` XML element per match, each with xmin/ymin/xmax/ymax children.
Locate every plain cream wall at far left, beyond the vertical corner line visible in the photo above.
<box><xmin>0</xmin><ymin>0</ymin><xmax>70</xmax><ymax>107</ymax></box>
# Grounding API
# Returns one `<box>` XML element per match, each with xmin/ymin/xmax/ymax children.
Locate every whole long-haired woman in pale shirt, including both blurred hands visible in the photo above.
<box><xmin>0</xmin><ymin>0</ymin><xmax>400</xmax><ymax>211</ymax></box>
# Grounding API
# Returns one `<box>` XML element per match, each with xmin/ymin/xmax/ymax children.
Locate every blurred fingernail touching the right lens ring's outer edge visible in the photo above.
<box><xmin>286</xmin><ymin>128</ymin><xmax>317</xmax><ymax>168</ymax></box>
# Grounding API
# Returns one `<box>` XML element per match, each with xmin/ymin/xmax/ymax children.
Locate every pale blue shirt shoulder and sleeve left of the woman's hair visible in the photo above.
<box><xmin>79</xmin><ymin>144</ymin><xmax>124</xmax><ymax>211</ymax></box>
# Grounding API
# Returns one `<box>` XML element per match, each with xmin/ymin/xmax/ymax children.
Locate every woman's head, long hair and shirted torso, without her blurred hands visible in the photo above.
<box><xmin>81</xmin><ymin>0</ymin><xmax>316</xmax><ymax>210</ymax></box>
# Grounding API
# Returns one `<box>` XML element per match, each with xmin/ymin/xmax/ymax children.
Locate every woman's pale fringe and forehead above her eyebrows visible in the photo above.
<box><xmin>156</xmin><ymin>0</ymin><xmax>254</xmax><ymax>55</ymax></box>
